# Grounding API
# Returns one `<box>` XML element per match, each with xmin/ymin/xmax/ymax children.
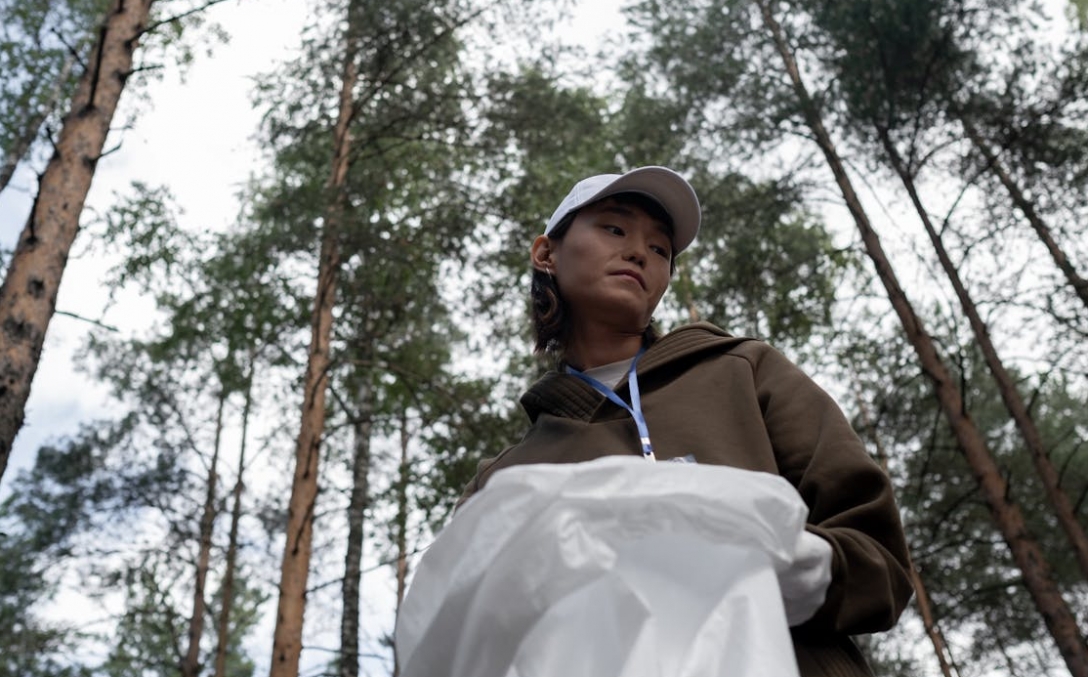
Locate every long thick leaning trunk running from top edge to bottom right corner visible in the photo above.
<box><xmin>756</xmin><ymin>0</ymin><xmax>1088</xmax><ymax>677</ymax></box>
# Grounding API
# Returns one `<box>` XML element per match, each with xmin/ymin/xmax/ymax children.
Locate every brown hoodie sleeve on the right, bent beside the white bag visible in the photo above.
<box><xmin>742</xmin><ymin>342</ymin><xmax>913</xmax><ymax>635</ymax></box>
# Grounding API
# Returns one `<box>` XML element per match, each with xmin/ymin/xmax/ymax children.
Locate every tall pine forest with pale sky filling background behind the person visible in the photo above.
<box><xmin>0</xmin><ymin>0</ymin><xmax>1088</xmax><ymax>677</ymax></box>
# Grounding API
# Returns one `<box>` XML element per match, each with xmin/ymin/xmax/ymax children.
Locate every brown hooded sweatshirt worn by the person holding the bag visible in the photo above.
<box><xmin>461</xmin><ymin>322</ymin><xmax>912</xmax><ymax>677</ymax></box>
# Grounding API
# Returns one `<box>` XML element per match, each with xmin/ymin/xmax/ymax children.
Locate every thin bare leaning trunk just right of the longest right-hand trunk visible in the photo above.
<box><xmin>877</xmin><ymin>128</ymin><xmax>1088</xmax><ymax>580</ymax></box>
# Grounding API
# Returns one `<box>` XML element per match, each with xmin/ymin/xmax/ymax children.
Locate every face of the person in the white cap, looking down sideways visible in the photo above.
<box><xmin>532</xmin><ymin>198</ymin><xmax>672</xmax><ymax>333</ymax></box>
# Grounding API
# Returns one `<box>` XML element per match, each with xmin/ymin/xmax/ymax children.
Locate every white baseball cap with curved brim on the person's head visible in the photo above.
<box><xmin>544</xmin><ymin>167</ymin><xmax>702</xmax><ymax>254</ymax></box>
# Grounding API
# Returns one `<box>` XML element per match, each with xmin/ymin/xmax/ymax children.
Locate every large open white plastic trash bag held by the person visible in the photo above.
<box><xmin>396</xmin><ymin>456</ymin><xmax>830</xmax><ymax>677</ymax></box>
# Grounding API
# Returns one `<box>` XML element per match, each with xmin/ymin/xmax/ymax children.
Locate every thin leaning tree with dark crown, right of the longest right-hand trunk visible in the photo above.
<box><xmin>815</xmin><ymin>2</ymin><xmax>1088</xmax><ymax>579</ymax></box>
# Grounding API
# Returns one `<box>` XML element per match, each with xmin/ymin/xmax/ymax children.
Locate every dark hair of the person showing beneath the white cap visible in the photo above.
<box><xmin>529</xmin><ymin>193</ymin><xmax>676</xmax><ymax>359</ymax></box>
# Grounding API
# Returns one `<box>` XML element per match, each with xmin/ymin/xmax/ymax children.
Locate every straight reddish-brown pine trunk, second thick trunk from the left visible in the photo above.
<box><xmin>269</xmin><ymin>2</ymin><xmax>359</xmax><ymax>677</ymax></box>
